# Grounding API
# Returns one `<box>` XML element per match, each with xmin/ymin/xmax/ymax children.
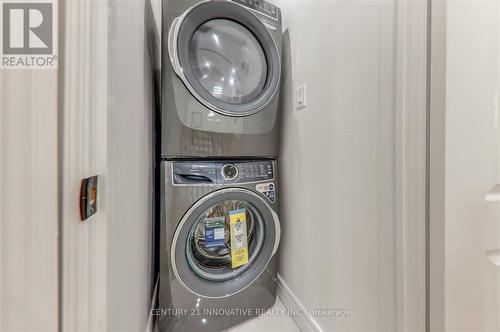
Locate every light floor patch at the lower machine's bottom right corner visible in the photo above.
<box><xmin>228</xmin><ymin>298</ymin><xmax>300</xmax><ymax>332</ymax></box>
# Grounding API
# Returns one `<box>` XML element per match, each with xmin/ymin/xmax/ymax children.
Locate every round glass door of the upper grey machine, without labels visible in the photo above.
<box><xmin>168</xmin><ymin>0</ymin><xmax>281</xmax><ymax>116</ymax></box>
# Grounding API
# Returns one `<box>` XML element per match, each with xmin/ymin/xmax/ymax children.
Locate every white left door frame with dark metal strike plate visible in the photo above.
<box><xmin>59</xmin><ymin>0</ymin><xmax>109</xmax><ymax>331</ymax></box>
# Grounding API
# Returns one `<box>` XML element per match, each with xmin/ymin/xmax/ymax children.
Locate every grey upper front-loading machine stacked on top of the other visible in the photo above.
<box><xmin>161</xmin><ymin>0</ymin><xmax>282</xmax><ymax>159</ymax></box>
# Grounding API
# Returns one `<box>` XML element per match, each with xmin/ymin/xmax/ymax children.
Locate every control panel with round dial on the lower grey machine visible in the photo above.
<box><xmin>172</xmin><ymin>160</ymin><xmax>274</xmax><ymax>185</ymax></box>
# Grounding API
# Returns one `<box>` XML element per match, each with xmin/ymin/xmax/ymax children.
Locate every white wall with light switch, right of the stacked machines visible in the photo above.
<box><xmin>277</xmin><ymin>0</ymin><xmax>402</xmax><ymax>331</ymax></box>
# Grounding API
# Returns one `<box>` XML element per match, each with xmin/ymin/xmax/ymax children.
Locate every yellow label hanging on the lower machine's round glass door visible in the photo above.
<box><xmin>229</xmin><ymin>209</ymin><xmax>248</xmax><ymax>269</ymax></box>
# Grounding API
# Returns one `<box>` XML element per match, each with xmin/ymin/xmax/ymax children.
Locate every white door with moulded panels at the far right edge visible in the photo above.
<box><xmin>444</xmin><ymin>1</ymin><xmax>500</xmax><ymax>331</ymax></box>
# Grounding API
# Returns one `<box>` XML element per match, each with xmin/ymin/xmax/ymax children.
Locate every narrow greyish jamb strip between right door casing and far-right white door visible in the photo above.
<box><xmin>426</xmin><ymin>0</ymin><xmax>447</xmax><ymax>332</ymax></box>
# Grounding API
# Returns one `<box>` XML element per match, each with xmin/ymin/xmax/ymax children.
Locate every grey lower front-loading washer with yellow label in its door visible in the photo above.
<box><xmin>159</xmin><ymin>160</ymin><xmax>281</xmax><ymax>331</ymax></box>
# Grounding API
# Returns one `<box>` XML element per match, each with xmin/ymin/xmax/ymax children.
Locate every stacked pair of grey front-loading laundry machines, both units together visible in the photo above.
<box><xmin>159</xmin><ymin>0</ymin><xmax>282</xmax><ymax>332</ymax></box>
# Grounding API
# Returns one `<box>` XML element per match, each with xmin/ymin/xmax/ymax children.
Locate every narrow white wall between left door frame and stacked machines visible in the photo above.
<box><xmin>106</xmin><ymin>0</ymin><xmax>153</xmax><ymax>331</ymax></box>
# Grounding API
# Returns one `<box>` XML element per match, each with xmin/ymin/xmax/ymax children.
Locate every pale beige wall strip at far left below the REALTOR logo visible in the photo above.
<box><xmin>0</xmin><ymin>70</ymin><xmax>58</xmax><ymax>331</ymax></box>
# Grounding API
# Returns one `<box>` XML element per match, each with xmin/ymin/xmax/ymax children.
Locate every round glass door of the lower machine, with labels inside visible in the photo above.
<box><xmin>171</xmin><ymin>188</ymin><xmax>280</xmax><ymax>298</ymax></box>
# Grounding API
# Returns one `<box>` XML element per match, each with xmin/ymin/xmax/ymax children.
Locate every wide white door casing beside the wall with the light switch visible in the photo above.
<box><xmin>395</xmin><ymin>0</ymin><xmax>429</xmax><ymax>331</ymax></box>
